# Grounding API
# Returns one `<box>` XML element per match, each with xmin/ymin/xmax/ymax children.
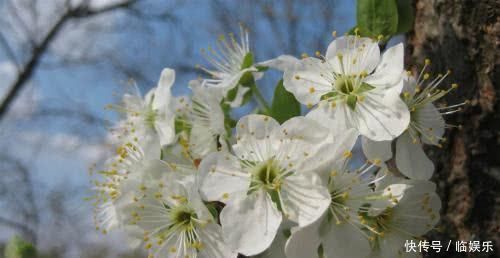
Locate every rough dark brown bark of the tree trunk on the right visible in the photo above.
<box><xmin>406</xmin><ymin>0</ymin><xmax>500</xmax><ymax>257</ymax></box>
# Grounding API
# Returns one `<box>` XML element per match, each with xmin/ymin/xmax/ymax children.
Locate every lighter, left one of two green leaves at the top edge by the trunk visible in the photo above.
<box><xmin>356</xmin><ymin>0</ymin><xmax>398</xmax><ymax>38</ymax></box>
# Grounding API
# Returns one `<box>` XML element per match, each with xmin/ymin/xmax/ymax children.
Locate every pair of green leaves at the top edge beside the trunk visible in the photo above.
<box><xmin>356</xmin><ymin>0</ymin><xmax>415</xmax><ymax>41</ymax></box>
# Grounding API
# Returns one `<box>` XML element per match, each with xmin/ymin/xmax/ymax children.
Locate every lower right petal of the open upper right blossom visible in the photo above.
<box><xmin>352</xmin><ymin>90</ymin><xmax>410</xmax><ymax>141</ymax></box>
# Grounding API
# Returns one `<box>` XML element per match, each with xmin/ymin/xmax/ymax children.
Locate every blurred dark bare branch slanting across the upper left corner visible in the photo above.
<box><xmin>0</xmin><ymin>0</ymin><xmax>138</xmax><ymax>120</ymax></box>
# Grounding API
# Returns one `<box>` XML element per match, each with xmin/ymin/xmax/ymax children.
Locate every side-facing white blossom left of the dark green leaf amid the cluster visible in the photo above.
<box><xmin>188</xmin><ymin>81</ymin><xmax>227</xmax><ymax>158</ymax></box>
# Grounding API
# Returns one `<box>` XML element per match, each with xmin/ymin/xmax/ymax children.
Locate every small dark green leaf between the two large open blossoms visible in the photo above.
<box><xmin>271</xmin><ymin>80</ymin><xmax>300</xmax><ymax>123</ymax></box>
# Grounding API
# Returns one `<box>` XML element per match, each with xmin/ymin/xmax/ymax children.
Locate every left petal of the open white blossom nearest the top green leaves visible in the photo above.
<box><xmin>283</xmin><ymin>57</ymin><xmax>333</xmax><ymax>105</ymax></box>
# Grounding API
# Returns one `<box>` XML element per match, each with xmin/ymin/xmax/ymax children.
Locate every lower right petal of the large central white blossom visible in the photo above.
<box><xmin>281</xmin><ymin>173</ymin><xmax>331</xmax><ymax>227</ymax></box>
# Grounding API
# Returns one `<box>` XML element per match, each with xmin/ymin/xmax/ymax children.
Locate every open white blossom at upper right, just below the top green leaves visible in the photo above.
<box><xmin>284</xmin><ymin>36</ymin><xmax>410</xmax><ymax>141</ymax></box>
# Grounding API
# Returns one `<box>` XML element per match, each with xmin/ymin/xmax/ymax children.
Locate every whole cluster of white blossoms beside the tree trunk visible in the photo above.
<box><xmin>93</xmin><ymin>29</ymin><xmax>465</xmax><ymax>258</ymax></box>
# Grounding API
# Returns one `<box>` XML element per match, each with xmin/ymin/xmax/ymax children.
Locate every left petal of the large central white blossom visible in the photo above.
<box><xmin>199</xmin><ymin>153</ymin><xmax>250</xmax><ymax>202</ymax></box>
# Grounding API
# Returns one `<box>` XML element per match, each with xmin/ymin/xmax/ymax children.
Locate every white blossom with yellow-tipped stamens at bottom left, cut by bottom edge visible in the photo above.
<box><xmin>131</xmin><ymin>176</ymin><xmax>238</xmax><ymax>258</ymax></box>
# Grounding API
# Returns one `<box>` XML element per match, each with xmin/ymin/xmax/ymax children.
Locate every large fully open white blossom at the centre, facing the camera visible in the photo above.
<box><xmin>200</xmin><ymin>115</ymin><xmax>341</xmax><ymax>255</ymax></box>
